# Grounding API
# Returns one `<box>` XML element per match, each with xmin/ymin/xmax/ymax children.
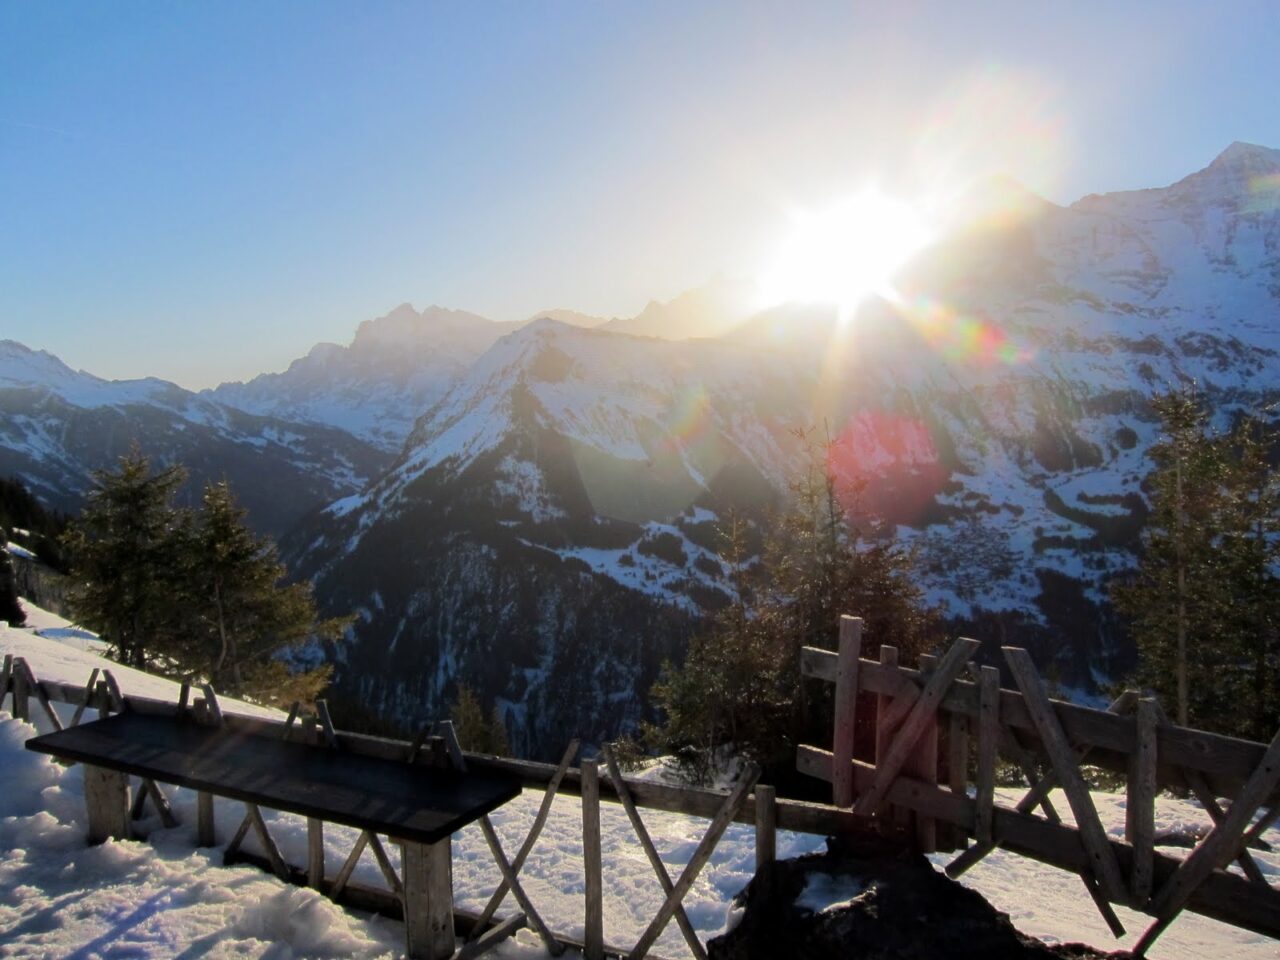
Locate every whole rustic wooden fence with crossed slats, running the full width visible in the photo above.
<box><xmin>0</xmin><ymin>627</ymin><xmax>1280</xmax><ymax>959</ymax></box>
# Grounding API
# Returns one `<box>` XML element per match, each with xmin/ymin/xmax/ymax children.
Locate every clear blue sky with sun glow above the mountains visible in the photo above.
<box><xmin>0</xmin><ymin>0</ymin><xmax>1280</xmax><ymax>389</ymax></box>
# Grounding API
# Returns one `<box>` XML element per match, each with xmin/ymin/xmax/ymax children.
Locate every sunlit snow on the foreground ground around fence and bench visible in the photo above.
<box><xmin>0</xmin><ymin>607</ymin><xmax>1280</xmax><ymax>960</ymax></box>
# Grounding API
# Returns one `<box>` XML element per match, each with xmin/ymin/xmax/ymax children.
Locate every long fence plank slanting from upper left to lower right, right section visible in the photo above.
<box><xmin>1004</xmin><ymin>646</ymin><xmax>1126</xmax><ymax>902</ymax></box>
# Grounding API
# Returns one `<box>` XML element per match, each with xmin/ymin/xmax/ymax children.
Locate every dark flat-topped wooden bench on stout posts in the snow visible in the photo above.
<box><xmin>27</xmin><ymin>712</ymin><xmax>521</xmax><ymax>960</ymax></box>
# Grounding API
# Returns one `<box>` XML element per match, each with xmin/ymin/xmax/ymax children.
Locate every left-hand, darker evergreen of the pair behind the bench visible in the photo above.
<box><xmin>63</xmin><ymin>447</ymin><xmax>186</xmax><ymax>667</ymax></box>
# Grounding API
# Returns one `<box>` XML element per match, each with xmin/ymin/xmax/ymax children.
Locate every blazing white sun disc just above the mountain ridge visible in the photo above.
<box><xmin>760</xmin><ymin>189</ymin><xmax>933</xmax><ymax>316</ymax></box>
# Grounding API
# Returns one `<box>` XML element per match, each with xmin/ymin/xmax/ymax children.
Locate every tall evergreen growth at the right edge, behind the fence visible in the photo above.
<box><xmin>1112</xmin><ymin>388</ymin><xmax>1280</xmax><ymax>737</ymax></box>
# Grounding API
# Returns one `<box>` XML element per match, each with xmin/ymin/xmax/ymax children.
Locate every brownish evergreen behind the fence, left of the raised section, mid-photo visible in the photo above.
<box><xmin>645</xmin><ymin>435</ymin><xmax>937</xmax><ymax>780</ymax></box>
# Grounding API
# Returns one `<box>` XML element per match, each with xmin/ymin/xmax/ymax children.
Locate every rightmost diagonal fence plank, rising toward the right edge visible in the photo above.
<box><xmin>1134</xmin><ymin>732</ymin><xmax>1280</xmax><ymax>955</ymax></box>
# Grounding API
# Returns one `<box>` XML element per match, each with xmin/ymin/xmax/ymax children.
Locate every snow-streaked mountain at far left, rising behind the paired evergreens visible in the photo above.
<box><xmin>0</xmin><ymin>340</ymin><xmax>388</xmax><ymax>535</ymax></box>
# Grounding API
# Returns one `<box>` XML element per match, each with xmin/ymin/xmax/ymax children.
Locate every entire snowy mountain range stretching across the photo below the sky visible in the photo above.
<box><xmin>0</xmin><ymin>143</ymin><xmax>1280</xmax><ymax>754</ymax></box>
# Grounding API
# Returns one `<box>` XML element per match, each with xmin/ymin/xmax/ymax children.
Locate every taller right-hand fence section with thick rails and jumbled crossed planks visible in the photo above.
<box><xmin>796</xmin><ymin>617</ymin><xmax>1280</xmax><ymax>955</ymax></box>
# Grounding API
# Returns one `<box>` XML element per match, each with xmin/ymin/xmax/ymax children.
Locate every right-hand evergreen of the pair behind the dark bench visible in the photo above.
<box><xmin>175</xmin><ymin>481</ymin><xmax>346</xmax><ymax>703</ymax></box>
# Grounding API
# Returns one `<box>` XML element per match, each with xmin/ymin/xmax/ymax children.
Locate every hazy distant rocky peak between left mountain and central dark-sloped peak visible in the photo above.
<box><xmin>205</xmin><ymin>303</ymin><xmax>518</xmax><ymax>454</ymax></box>
